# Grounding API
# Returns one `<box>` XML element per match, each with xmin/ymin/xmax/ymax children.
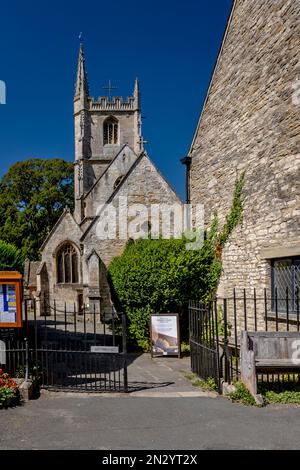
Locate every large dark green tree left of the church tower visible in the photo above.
<box><xmin>0</xmin><ymin>159</ymin><xmax>74</xmax><ymax>260</ymax></box>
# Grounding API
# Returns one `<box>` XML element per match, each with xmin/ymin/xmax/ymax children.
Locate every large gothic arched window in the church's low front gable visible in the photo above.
<box><xmin>57</xmin><ymin>243</ymin><xmax>79</xmax><ymax>284</ymax></box>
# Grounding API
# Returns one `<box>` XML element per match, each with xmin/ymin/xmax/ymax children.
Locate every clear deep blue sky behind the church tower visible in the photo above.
<box><xmin>0</xmin><ymin>0</ymin><xmax>232</xmax><ymax>196</ymax></box>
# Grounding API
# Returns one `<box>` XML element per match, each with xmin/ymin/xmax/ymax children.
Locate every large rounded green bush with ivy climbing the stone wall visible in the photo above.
<box><xmin>108</xmin><ymin>175</ymin><xmax>244</xmax><ymax>350</ymax></box>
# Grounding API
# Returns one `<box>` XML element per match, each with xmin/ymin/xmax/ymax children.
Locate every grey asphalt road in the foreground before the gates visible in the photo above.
<box><xmin>0</xmin><ymin>393</ymin><xmax>300</xmax><ymax>450</ymax></box>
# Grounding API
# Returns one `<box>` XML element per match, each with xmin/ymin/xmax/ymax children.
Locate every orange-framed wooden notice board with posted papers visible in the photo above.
<box><xmin>0</xmin><ymin>271</ymin><xmax>22</xmax><ymax>328</ymax></box>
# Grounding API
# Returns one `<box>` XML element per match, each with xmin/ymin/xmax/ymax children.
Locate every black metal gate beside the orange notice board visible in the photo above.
<box><xmin>0</xmin><ymin>301</ymin><xmax>128</xmax><ymax>392</ymax></box>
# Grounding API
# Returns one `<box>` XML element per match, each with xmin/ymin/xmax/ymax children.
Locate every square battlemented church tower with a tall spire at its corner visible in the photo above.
<box><xmin>74</xmin><ymin>42</ymin><xmax>143</xmax><ymax>223</ymax></box>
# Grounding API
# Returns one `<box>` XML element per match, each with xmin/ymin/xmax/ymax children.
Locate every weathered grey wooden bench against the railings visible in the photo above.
<box><xmin>240</xmin><ymin>331</ymin><xmax>300</xmax><ymax>404</ymax></box>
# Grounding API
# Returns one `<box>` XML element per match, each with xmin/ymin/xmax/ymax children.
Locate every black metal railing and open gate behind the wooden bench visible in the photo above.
<box><xmin>189</xmin><ymin>289</ymin><xmax>300</xmax><ymax>390</ymax></box>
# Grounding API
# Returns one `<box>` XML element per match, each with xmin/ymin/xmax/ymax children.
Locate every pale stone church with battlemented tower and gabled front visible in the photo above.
<box><xmin>25</xmin><ymin>44</ymin><xmax>181</xmax><ymax>314</ymax></box>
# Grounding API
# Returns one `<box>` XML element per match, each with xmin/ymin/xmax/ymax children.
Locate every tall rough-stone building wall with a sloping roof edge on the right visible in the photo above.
<box><xmin>188</xmin><ymin>0</ymin><xmax>300</xmax><ymax>316</ymax></box>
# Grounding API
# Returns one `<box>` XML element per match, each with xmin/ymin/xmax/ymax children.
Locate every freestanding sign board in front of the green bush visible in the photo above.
<box><xmin>150</xmin><ymin>313</ymin><xmax>180</xmax><ymax>357</ymax></box>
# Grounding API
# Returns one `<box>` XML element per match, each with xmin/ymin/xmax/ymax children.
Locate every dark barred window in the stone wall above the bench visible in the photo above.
<box><xmin>272</xmin><ymin>258</ymin><xmax>300</xmax><ymax>313</ymax></box>
